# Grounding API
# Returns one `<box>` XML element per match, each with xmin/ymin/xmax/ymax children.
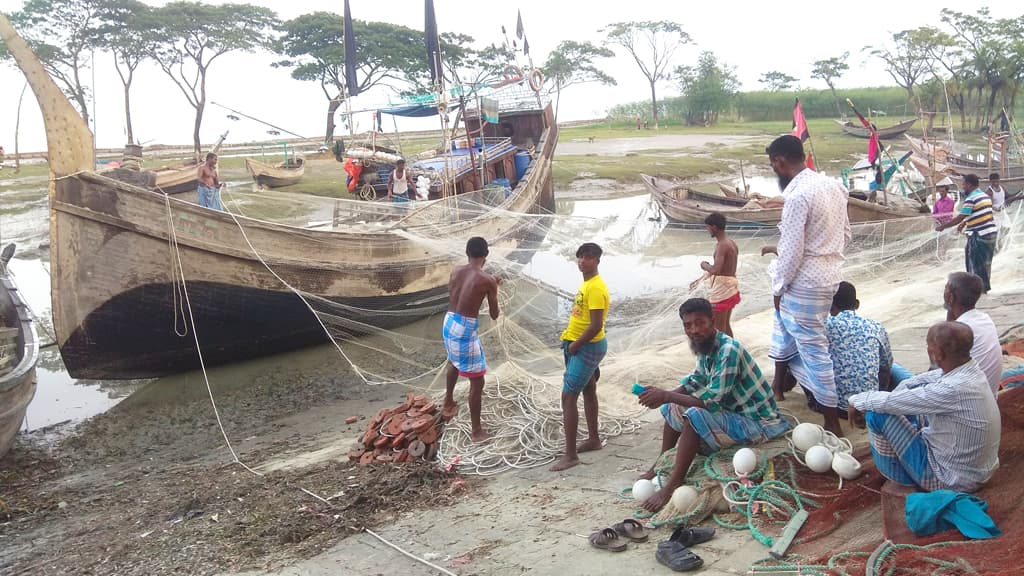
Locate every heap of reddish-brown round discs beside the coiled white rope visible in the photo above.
<box><xmin>348</xmin><ymin>393</ymin><xmax>441</xmax><ymax>464</ymax></box>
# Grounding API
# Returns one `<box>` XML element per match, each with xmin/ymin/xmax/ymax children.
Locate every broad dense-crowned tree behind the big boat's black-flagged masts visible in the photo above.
<box><xmin>273</xmin><ymin>12</ymin><xmax>427</xmax><ymax>142</ymax></box>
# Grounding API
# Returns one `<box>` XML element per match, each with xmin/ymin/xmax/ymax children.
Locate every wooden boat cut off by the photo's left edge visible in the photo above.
<box><xmin>0</xmin><ymin>244</ymin><xmax>39</xmax><ymax>458</ymax></box>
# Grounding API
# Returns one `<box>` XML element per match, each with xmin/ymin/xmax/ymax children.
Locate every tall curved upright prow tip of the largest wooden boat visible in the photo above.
<box><xmin>0</xmin><ymin>13</ymin><xmax>95</xmax><ymax>176</ymax></box>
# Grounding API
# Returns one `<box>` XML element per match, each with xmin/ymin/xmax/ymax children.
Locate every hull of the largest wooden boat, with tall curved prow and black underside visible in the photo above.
<box><xmin>0</xmin><ymin>14</ymin><xmax>558</xmax><ymax>379</ymax></box>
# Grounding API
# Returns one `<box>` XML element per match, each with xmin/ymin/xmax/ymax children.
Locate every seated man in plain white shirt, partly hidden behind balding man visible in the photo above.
<box><xmin>892</xmin><ymin>272</ymin><xmax>1002</xmax><ymax>395</ymax></box>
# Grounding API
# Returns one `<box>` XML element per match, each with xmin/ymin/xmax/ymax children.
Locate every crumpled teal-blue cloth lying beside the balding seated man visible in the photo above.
<box><xmin>906</xmin><ymin>490</ymin><xmax>1002</xmax><ymax>539</ymax></box>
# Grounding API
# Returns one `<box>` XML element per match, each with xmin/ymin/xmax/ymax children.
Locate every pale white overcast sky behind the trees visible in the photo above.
<box><xmin>0</xmin><ymin>0</ymin><xmax>1024</xmax><ymax>154</ymax></box>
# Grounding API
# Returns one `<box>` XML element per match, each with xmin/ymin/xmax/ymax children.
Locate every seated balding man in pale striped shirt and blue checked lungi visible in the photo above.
<box><xmin>849</xmin><ymin>322</ymin><xmax>1000</xmax><ymax>492</ymax></box>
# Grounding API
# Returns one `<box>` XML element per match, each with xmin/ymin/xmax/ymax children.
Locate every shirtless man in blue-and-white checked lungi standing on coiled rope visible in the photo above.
<box><xmin>442</xmin><ymin>237</ymin><xmax>502</xmax><ymax>442</ymax></box>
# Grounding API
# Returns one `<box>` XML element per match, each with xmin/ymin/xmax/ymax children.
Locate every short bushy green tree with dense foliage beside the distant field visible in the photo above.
<box><xmin>675</xmin><ymin>51</ymin><xmax>739</xmax><ymax>126</ymax></box>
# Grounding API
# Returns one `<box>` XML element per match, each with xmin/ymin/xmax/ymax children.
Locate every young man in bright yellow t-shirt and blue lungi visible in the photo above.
<box><xmin>551</xmin><ymin>242</ymin><xmax>611</xmax><ymax>471</ymax></box>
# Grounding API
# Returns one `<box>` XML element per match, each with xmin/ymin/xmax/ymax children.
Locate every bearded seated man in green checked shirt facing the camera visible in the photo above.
<box><xmin>640</xmin><ymin>298</ymin><xmax>790</xmax><ymax>511</ymax></box>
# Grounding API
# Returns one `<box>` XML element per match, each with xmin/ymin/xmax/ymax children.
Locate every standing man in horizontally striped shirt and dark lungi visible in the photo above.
<box><xmin>935</xmin><ymin>174</ymin><xmax>999</xmax><ymax>293</ymax></box>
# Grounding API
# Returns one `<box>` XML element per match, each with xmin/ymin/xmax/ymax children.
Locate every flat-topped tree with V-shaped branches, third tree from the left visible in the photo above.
<box><xmin>150</xmin><ymin>1</ymin><xmax>278</xmax><ymax>155</ymax></box>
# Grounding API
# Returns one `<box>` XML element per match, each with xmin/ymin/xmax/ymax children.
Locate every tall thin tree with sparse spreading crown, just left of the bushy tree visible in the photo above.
<box><xmin>600</xmin><ymin>20</ymin><xmax>690</xmax><ymax>128</ymax></box>
